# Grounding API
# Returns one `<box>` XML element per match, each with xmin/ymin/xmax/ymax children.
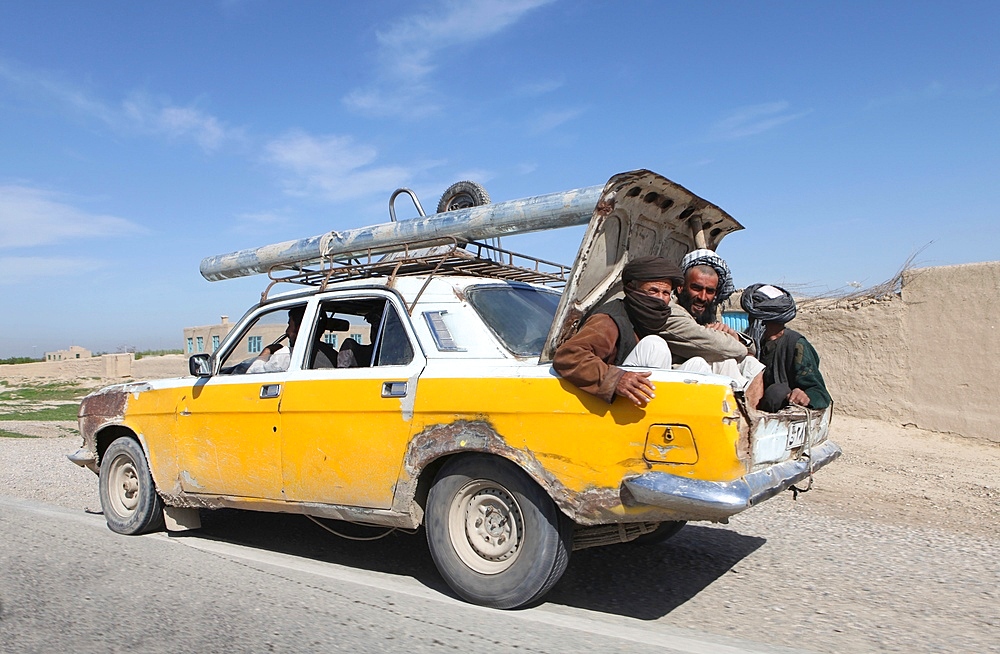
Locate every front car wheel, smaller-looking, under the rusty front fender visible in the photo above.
<box><xmin>100</xmin><ymin>437</ymin><xmax>163</xmax><ymax>535</ymax></box>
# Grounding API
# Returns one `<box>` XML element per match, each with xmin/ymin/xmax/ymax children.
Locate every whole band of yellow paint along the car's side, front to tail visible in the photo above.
<box><xmin>117</xmin><ymin>369</ymin><xmax>747</xmax><ymax>513</ymax></box>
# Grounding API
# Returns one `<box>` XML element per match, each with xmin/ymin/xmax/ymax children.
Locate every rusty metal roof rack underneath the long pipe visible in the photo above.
<box><xmin>261</xmin><ymin>237</ymin><xmax>570</xmax><ymax>310</ymax></box>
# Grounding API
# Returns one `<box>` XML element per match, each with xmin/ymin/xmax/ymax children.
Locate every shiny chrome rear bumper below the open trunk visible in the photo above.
<box><xmin>624</xmin><ymin>441</ymin><xmax>841</xmax><ymax>520</ymax></box>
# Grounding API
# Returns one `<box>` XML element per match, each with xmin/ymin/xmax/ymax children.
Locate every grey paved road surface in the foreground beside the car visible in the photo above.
<box><xmin>0</xmin><ymin>497</ymin><xmax>789</xmax><ymax>654</ymax></box>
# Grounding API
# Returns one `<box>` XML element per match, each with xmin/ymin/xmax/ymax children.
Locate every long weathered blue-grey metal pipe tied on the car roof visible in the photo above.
<box><xmin>200</xmin><ymin>186</ymin><xmax>604</xmax><ymax>282</ymax></box>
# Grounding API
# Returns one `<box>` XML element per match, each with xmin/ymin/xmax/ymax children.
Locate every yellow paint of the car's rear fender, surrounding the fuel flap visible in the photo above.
<box><xmin>413</xmin><ymin>377</ymin><xmax>747</xmax><ymax>491</ymax></box>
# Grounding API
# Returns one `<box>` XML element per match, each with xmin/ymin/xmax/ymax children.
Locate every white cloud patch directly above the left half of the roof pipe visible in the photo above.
<box><xmin>265</xmin><ymin>132</ymin><xmax>412</xmax><ymax>202</ymax></box>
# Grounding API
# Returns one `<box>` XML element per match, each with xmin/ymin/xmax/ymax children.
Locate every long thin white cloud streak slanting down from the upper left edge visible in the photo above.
<box><xmin>0</xmin><ymin>60</ymin><xmax>244</xmax><ymax>151</ymax></box>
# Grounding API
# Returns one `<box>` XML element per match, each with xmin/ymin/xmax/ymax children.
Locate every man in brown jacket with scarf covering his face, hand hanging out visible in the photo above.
<box><xmin>552</xmin><ymin>257</ymin><xmax>683</xmax><ymax>407</ymax></box>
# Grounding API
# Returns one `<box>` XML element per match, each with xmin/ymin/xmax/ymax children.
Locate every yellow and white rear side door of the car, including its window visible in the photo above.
<box><xmin>281</xmin><ymin>293</ymin><xmax>424</xmax><ymax>509</ymax></box>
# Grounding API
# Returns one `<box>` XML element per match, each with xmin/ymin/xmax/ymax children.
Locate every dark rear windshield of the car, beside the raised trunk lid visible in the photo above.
<box><xmin>467</xmin><ymin>284</ymin><xmax>559</xmax><ymax>357</ymax></box>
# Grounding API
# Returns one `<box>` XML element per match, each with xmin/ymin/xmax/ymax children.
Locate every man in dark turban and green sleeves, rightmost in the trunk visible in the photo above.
<box><xmin>740</xmin><ymin>284</ymin><xmax>833</xmax><ymax>411</ymax></box>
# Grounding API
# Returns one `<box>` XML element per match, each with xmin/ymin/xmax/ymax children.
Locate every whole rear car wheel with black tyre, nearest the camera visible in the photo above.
<box><xmin>424</xmin><ymin>456</ymin><xmax>573</xmax><ymax>609</ymax></box>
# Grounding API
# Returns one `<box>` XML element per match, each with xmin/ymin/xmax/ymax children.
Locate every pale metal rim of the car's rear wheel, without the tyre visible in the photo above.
<box><xmin>448</xmin><ymin>479</ymin><xmax>524</xmax><ymax>575</ymax></box>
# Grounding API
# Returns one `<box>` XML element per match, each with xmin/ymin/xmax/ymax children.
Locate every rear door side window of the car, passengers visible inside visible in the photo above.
<box><xmin>306</xmin><ymin>297</ymin><xmax>414</xmax><ymax>370</ymax></box>
